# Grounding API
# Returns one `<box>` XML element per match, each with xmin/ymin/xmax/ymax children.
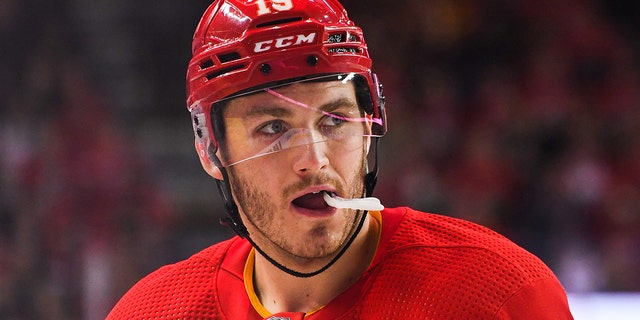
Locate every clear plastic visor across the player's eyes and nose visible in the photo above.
<box><xmin>215</xmin><ymin>74</ymin><xmax>384</xmax><ymax>167</ymax></box>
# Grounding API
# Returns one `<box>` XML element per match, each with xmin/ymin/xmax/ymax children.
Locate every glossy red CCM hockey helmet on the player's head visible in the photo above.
<box><xmin>187</xmin><ymin>0</ymin><xmax>386</xmax><ymax>161</ymax></box>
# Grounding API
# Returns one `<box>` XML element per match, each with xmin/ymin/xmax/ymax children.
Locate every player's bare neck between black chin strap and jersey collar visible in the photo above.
<box><xmin>253</xmin><ymin>215</ymin><xmax>379</xmax><ymax>313</ymax></box>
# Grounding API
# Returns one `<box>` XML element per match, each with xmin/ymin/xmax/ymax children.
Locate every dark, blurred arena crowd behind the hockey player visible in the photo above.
<box><xmin>0</xmin><ymin>0</ymin><xmax>640</xmax><ymax>320</ymax></box>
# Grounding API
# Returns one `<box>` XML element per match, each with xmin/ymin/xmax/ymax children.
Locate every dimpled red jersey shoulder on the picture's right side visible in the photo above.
<box><xmin>359</xmin><ymin>208</ymin><xmax>570</xmax><ymax>319</ymax></box>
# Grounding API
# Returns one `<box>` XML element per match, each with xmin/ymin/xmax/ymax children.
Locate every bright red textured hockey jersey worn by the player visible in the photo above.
<box><xmin>107</xmin><ymin>208</ymin><xmax>572</xmax><ymax>320</ymax></box>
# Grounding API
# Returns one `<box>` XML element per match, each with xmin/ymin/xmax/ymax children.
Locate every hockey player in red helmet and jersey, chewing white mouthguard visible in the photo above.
<box><xmin>108</xmin><ymin>0</ymin><xmax>572</xmax><ymax>320</ymax></box>
